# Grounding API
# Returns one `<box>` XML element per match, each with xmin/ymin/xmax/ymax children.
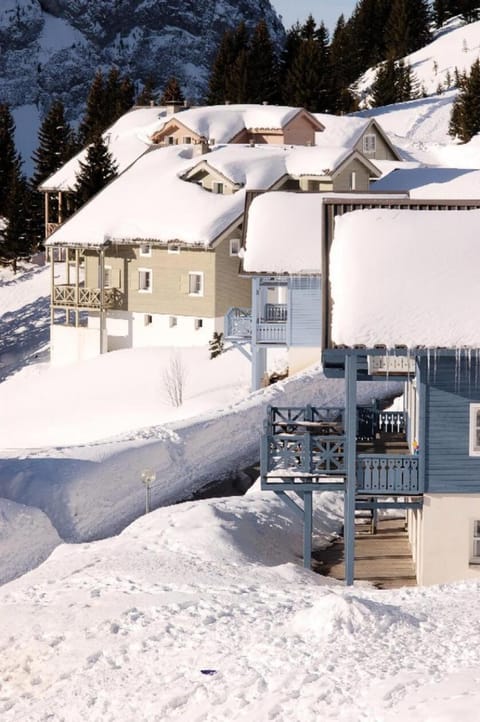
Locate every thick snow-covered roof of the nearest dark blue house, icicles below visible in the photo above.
<box><xmin>330</xmin><ymin>209</ymin><xmax>480</xmax><ymax>348</ymax></box>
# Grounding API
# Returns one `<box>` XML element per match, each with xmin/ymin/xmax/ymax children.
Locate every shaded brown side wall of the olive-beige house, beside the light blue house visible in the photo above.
<box><xmin>215</xmin><ymin>229</ymin><xmax>252</xmax><ymax>317</ymax></box>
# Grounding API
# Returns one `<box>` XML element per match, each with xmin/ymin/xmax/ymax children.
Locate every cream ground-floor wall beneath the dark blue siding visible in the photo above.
<box><xmin>416</xmin><ymin>494</ymin><xmax>480</xmax><ymax>584</ymax></box>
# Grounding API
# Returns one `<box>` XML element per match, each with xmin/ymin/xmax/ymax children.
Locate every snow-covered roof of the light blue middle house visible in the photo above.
<box><xmin>243</xmin><ymin>191</ymin><xmax>322</xmax><ymax>273</ymax></box>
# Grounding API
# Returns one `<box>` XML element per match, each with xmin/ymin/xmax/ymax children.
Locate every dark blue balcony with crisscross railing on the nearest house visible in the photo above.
<box><xmin>260</xmin><ymin>406</ymin><xmax>423</xmax><ymax>496</ymax></box>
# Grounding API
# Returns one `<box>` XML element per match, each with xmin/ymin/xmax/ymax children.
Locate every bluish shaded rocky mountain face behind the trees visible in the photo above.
<box><xmin>0</xmin><ymin>0</ymin><xmax>284</xmax><ymax>118</ymax></box>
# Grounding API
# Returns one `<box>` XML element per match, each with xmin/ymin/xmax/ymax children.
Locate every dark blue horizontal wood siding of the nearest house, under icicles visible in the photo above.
<box><xmin>420</xmin><ymin>356</ymin><xmax>480</xmax><ymax>494</ymax></box>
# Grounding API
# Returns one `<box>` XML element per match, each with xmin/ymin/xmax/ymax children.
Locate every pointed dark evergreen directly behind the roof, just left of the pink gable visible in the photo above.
<box><xmin>247</xmin><ymin>20</ymin><xmax>279</xmax><ymax>103</ymax></box>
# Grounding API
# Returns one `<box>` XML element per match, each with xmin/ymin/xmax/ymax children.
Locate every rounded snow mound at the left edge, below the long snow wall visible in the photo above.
<box><xmin>0</xmin><ymin>499</ymin><xmax>61</xmax><ymax>584</ymax></box>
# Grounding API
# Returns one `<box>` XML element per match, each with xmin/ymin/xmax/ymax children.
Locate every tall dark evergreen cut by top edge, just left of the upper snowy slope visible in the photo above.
<box><xmin>385</xmin><ymin>0</ymin><xmax>430</xmax><ymax>58</ymax></box>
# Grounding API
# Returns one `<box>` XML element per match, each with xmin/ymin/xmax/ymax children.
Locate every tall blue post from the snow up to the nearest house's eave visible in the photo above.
<box><xmin>343</xmin><ymin>353</ymin><xmax>357</xmax><ymax>586</ymax></box>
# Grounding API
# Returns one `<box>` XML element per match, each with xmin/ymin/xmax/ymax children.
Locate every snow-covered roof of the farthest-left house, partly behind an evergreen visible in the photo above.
<box><xmin>40</xmin><ymin>106</ymin><xmax>165</xmax><ymax>191</ymax></box>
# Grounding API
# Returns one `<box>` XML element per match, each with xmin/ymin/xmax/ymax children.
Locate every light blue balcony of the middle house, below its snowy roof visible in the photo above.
<box><xmin>225</xmin><ymin>303</ymin><xmax>287</xmax><ymax>345</ymax></box>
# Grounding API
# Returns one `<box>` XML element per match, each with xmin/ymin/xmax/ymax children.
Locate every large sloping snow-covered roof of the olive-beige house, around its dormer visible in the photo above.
<box><xmin>47</xmin><ymin>146</ymin><xmax>300</xmax><ymax>246</ymax></box>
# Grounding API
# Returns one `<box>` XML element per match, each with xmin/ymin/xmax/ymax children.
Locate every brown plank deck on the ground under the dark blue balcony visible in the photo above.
<box><xmin>312</xmin><ymin>519</ymin><xmax>417</xmax><ymax>589</ymax></box>
